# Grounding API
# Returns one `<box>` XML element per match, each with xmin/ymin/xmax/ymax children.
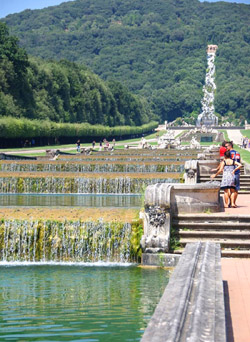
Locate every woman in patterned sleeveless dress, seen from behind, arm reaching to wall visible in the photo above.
<box><xmin>211</xmin><ymin>151</ymin><xmax>242</xmax><ymax>208</ymax></box>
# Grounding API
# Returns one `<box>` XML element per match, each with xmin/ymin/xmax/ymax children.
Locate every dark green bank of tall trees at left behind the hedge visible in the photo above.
<box><xmin>0</xmin><ymin>23</ymin><xmax>153</xmax><ymax>127</ymax></box>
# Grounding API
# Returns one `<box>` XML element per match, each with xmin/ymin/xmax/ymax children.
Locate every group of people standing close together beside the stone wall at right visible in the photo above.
<box><xmin>211</xmin><ymin>141</ymin><xmax>242</xmax><ymax>208</ymax></box>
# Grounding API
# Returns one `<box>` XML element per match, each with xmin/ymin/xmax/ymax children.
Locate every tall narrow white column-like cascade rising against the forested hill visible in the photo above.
<box><xmin>196</xmin><ymin>45</ymin><xmax>218</xmax><ymax>127</ymax></box>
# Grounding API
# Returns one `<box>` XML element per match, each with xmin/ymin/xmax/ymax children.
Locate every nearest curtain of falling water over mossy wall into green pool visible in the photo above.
<box><xmin>0</xmin><ymin>220</ymin><xmax>133</xmax><ymax>262</ymax></box>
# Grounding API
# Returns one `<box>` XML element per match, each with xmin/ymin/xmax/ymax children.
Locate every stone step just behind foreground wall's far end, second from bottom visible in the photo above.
<box><xmin>179</xmin><ymin>237</ymin><xmax>250</xmax><ymax>250</ymax></box>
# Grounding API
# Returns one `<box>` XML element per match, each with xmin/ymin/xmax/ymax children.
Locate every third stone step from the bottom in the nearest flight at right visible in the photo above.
<box><xmin>179</xmin><ymin>227</ymin><xmax>250</xmax><ymax>240</ymax></box>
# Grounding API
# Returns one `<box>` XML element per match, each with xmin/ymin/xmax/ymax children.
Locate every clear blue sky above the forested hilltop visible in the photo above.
<box><xmin>0</xmin><ymin>0</ymin><xmax>250</xmax><ymax>18</ymax></box>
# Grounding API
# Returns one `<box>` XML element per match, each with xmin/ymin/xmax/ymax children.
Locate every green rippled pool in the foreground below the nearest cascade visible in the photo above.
<box><xmin>0</xmin><ymin>264</ymin><xmax>169</xmax><ymax>342</ymax></box>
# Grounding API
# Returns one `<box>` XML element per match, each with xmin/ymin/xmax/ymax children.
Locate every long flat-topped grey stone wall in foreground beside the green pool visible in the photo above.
<box><xmin>141</xmin><ymin>242</ymin><xmax>226</xmax><ymax>342</ymax></box>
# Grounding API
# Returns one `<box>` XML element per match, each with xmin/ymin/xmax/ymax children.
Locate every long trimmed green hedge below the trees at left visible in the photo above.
<box><xmin>0</xmin><ymin>117</ymin><xmax>158</xmax><ymax>139</ymax></box>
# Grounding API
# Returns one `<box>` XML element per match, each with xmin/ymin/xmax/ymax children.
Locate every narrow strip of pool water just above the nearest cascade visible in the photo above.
<box><xmin>0</xmin><ymin>194</ymin><xmax>142</xmax><ymax>208</ymax></box>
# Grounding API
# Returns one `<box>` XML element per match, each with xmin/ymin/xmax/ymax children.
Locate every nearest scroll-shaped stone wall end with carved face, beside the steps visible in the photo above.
<box><xmin>141</xmin><ymin>182</ymin><xmax>220</xmax><ymax>253</ymax></box>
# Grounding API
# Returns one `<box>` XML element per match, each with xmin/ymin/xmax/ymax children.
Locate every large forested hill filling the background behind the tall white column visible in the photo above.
<box><xmin>4</xmin><ymin>0</ymin><xmax>250</xmax><ymax>120</ymax></box>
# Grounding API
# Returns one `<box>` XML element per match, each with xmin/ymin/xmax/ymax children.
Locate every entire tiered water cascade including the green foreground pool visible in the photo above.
<box><xmin>0</xmin><ymin>150</ymin><xmax>202</xmax><ymax>341</ymax></box>
